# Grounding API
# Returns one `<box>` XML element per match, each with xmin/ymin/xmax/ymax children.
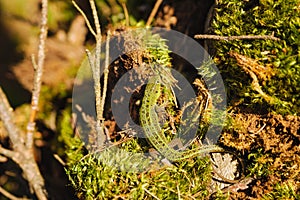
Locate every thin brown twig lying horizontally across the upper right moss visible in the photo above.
<box><xmin>194</xmin><ymin>34</ymin><xmax>280</xmax><ymax>41</ymax></box>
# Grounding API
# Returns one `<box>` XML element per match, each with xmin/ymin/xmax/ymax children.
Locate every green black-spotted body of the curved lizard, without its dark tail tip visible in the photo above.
<box><xmin>140</xmin><ymin>74</ymin><xmax>224</xmax><ymax>161</ymax></box>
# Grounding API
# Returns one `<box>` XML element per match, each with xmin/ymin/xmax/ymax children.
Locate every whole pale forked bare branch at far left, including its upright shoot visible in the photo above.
<box><xmin>0</xmin><ymin>0</ymin><xmax>48</xmax><ymax>200</ymax></box>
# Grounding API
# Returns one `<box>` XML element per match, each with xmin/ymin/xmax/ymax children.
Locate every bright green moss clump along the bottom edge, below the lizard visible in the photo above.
<box><xmin>59</xmin><ymin>108</ymin><xmax>211</xmax><ymax>199</ymax></box>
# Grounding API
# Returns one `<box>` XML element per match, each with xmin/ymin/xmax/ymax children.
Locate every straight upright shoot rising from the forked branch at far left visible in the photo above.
<box><xmin>26</xmin><ymin>0</ymin><xmax>48</xmax><ymax>148</ymax></box>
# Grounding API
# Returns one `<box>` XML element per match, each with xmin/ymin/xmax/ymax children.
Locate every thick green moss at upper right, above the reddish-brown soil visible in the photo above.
<box><xmin>212</xmin><ymin>0</ymin><xmax>300</xmax><ymax>114</ymax></box>
